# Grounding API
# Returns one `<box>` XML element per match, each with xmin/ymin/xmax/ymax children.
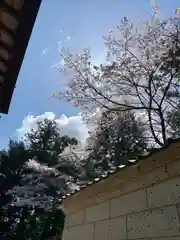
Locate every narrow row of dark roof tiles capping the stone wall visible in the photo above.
<box><xmin>60</xmin><ymin>138</ymin><xmax>180</xmax><ymax>202</ymax></box>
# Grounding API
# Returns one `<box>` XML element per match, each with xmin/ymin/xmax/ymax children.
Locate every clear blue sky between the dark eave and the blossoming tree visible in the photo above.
<box><xmin>0</xmin><ymin>0</ymin><xmax>180</xmax><ymax>148</ymax></box>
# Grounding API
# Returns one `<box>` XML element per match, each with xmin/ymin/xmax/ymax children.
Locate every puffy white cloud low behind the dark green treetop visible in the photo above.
<box><xmin>17</xmin><ymin>112</ymin><xmax>88</xmax><ymax>143</ymax></box>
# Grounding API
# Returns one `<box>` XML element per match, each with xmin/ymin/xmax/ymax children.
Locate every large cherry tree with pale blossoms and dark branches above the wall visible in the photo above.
<box><xmin>54</xmin><ymin>16</ymin><xmax>180</xmax><ymax>146</ymax></box>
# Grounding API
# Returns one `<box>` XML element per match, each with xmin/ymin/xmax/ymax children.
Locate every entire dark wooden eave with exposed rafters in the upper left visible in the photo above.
<box><xmin>0</xmin><ymin>0</ymin><xmax>41</xmax><ymax>114</ymax></box>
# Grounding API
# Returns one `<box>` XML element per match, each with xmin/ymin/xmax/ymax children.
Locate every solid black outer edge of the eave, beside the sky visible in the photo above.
<box><xmin>1</xmin><ymin>0</ymin><xmax>41</xmax><ymax>114</ymax></box>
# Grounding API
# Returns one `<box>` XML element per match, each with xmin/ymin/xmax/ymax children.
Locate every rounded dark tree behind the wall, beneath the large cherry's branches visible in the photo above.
<box><xmin>89</xmin><ymin>112</ymin><xmax>147</xmax><ymax>171</ymax></box>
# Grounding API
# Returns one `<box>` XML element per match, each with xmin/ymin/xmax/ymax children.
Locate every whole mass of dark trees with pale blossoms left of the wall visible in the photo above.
<box><xmin>0</xmin><ymin>119</ymin><xmax>80</xmax><ymax>240</ymax></box>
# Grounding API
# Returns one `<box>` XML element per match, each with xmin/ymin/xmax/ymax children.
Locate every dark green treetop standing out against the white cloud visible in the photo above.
<box><xmin>26</xmin><ymin>119</ymin><xmax>78</xmax><ymax>166</ymax></box>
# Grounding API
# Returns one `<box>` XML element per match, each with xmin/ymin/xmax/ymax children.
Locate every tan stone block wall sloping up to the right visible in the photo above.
<box><xmin>63</xmin><ymin>143</ymin><xmax>180</xmax><ymax>240</ymax></box>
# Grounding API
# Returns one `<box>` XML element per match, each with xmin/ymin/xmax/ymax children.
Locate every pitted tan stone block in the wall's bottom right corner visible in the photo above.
<box><xmin>127</xmin><ymin>206</ymin><xmax>180</xmax><ymax>239</ymax></box>
